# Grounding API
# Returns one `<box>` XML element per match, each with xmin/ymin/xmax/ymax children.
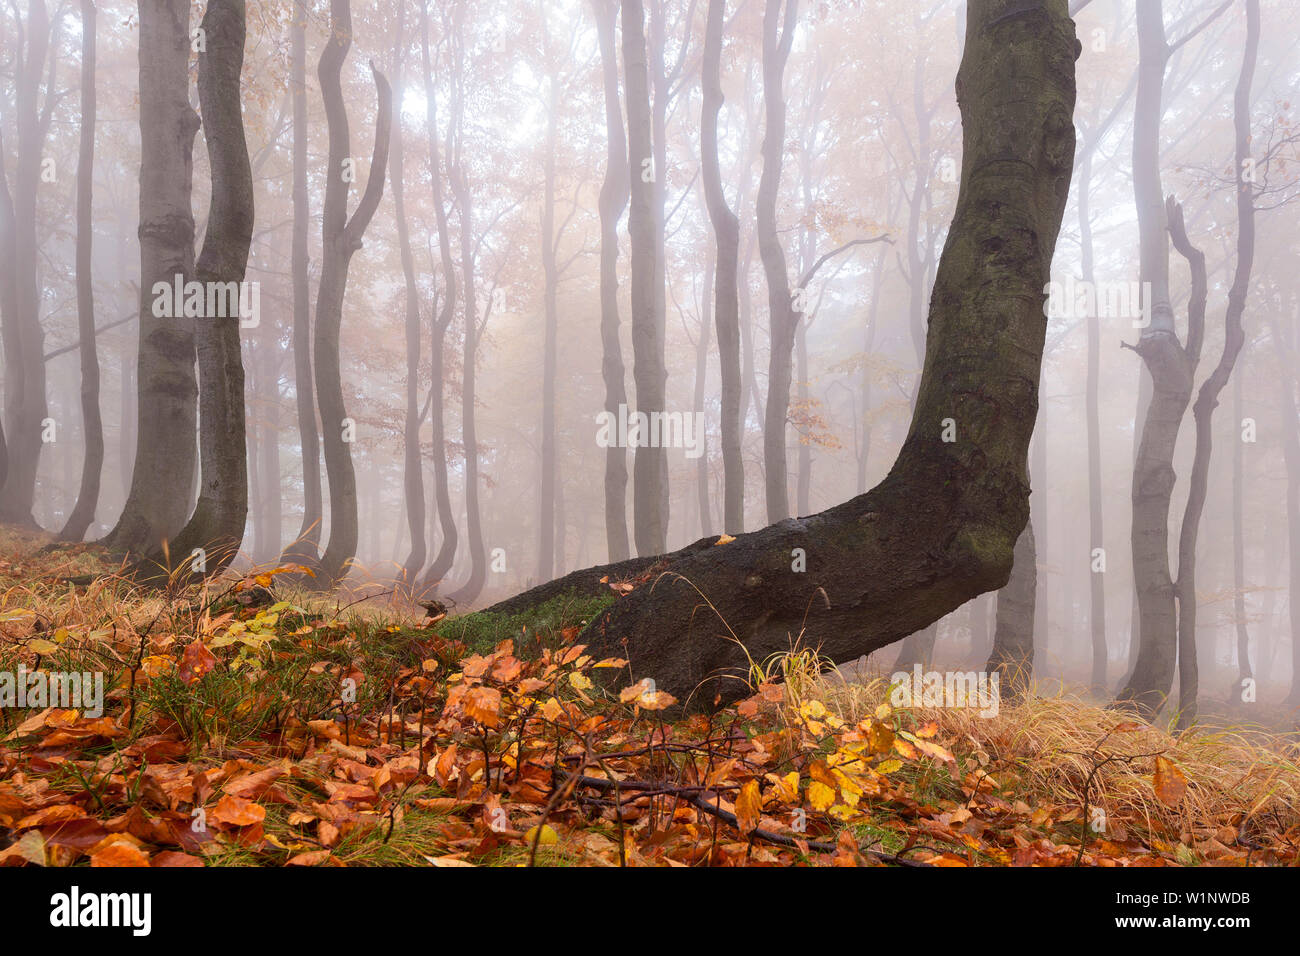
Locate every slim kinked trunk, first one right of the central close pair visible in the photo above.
<box><xmin>699</xmin><ymin>0</ymin><xmax>745</xmax><ymax>535</ymax></box>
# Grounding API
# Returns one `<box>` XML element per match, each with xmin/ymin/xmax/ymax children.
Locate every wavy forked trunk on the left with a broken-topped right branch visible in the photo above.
<box><xmin>315</xmin><ymin>0</ymin><xmax>393</xmax><ymax>585</ymax></box>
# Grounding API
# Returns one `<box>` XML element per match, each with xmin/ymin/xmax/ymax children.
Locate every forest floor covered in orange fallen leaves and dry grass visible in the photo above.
<box><xmin>0</xmin><ymin>529</ymin><xmax>1300</xmax><ymax>866</ymax></box>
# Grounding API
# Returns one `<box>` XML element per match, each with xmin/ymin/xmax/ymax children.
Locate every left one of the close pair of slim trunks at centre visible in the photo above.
<box><xmin>592</xmin><ymin>0</ymin><xmax>632</xmax><ymax>562</ymax></box>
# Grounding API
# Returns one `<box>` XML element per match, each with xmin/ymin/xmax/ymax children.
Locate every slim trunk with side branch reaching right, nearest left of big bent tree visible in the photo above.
<box><xmin>757</xmin><ymin>0</ymin><xmax>798</xmax><ymax>523</ymax></box>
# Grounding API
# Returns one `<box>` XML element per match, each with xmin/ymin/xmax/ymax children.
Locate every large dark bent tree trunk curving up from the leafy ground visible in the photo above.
<box><xmin>486</xmin><ymin>0</ymin><xmax>1079</xmax><ymax>708</ymax></box>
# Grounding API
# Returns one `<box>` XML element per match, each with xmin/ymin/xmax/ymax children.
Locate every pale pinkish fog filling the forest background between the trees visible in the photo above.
<box><xmin>0</xmin><ymin>0</ymin><xmax>1300</xmax><ymax>710</ymax></box>
